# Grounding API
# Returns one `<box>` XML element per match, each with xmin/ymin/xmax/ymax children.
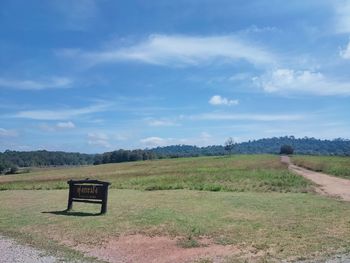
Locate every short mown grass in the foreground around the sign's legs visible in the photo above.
<box><xmin>0</xmin><ymin>189</ymin><xmax>350</xmax><ymax>259</ymax></box>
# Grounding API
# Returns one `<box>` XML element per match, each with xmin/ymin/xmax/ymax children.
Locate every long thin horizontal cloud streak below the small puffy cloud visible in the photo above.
<box><xmin>188</xmin><ymin>112</ymin><xmax>305</xmax><ymax>121</ymax></box>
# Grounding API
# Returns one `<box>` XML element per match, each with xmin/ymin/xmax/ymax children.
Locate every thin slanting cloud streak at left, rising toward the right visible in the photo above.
<box><xmin>13</xmin><ymin>104</ymin><xmax>108</xmax><ymax>120</ymax></box>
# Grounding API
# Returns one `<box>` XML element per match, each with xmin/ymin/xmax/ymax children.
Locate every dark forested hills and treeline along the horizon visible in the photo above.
<box><xmin>0</xmin><ymin>136</ymin><xmax>350</xmax><ymax>173</ymax></box>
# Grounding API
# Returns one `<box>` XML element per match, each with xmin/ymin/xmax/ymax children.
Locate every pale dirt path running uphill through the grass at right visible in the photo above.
<box><xmin>281</xmin><ymin>156</ymin><xmax>350</xmax><ymax>201</ymax></box>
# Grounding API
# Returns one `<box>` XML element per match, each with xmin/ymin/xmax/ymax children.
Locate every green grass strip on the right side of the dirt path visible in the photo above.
<box><xmin>293</xmin><ymin>155</ymin><xmax>350</xmax><ymax>179</ymax></box>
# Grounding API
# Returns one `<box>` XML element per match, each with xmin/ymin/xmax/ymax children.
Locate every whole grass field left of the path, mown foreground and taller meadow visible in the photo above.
<box><xmin>0</xmin><ymin>155</ymin><xmax>350</xmax><ymax>262</ymax></box>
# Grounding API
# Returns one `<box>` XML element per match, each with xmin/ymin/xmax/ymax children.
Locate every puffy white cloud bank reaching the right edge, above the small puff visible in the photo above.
<box><xmin>253</xmin><ymin>69</ymin><xmax>350</xmax><ymax>96</ymax></box>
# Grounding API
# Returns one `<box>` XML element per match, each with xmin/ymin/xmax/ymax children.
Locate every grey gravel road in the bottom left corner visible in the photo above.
<box><xmin>0</xmin><ymin>236</ymin><xmax>59</xmax><ymax>263</ymax></box>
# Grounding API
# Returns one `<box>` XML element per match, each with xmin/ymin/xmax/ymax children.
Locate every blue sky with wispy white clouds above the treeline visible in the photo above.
<box><xmin>0</xmin><ymin>0</ymin><xmax>350</xmax><ymax>153</ymax></box>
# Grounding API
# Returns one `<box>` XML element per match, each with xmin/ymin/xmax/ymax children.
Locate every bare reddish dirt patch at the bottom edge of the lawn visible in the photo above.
<box><xmin>79</xmin><ymin>234</ymin><xmax>243</xmax><ymax>263</ymax></box>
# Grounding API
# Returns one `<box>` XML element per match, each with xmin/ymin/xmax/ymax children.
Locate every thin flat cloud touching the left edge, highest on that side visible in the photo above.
<box><xmin>0</xmin><ymin>77</ymin><xmax>73</xmax><ymax>90</ymax></box>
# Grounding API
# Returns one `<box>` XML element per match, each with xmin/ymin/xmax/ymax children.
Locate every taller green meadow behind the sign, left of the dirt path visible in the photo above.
<box><xmin>0</xmin><ymin>155</ymin><xmax>310</xmax><ymax>192</ymax></box>
